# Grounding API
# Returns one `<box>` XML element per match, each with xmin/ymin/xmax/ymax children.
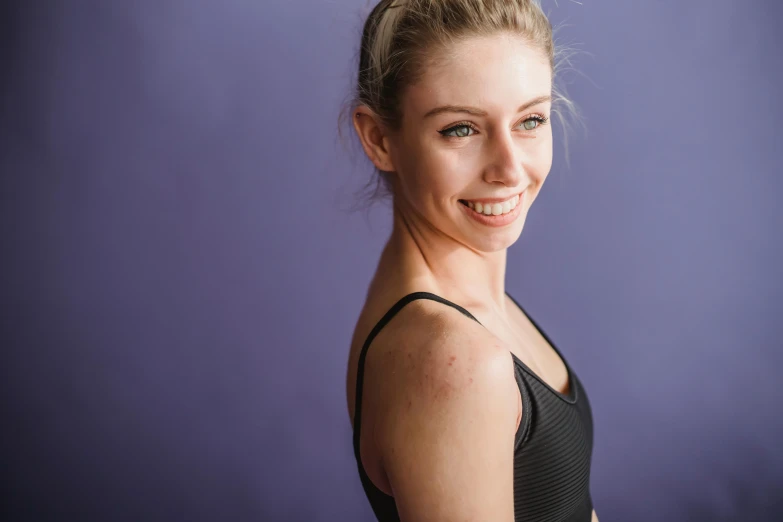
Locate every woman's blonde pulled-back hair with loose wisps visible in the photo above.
<box><xmin>343</xmin><ymin>0</ymin><xmax>575</xmax><ymax>207</ymax></box>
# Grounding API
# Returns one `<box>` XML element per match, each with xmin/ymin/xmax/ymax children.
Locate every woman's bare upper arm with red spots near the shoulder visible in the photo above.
<box><xmin>378</xmin><ymin>316</ymin><xmax>519</xmax><ymax>522</ymax></box>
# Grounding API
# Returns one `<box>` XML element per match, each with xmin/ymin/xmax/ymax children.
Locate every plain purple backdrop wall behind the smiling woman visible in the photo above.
<box><xmin>0</xmin><ymin>0</ymin><xmax>783</xmax><ymax>522</ymax></box>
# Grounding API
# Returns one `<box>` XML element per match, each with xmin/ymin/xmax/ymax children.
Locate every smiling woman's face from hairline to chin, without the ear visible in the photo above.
<box><xmin>389</xmin><ymin>34</ymin><xmax>552</xmax><ymax>252</ymax></box>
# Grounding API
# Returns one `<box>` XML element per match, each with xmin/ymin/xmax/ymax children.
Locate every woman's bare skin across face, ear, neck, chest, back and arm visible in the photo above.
<box><xmin>346</xmin><ymin>33</ymin><xmax>598</xmax><ymax>522</ymax></box>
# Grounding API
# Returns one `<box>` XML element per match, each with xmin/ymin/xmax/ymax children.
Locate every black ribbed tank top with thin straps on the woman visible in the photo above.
<box><xmin>353</xmin><ymin>292</ymin><xmax>593</xmax><ymax>522</ymax></box>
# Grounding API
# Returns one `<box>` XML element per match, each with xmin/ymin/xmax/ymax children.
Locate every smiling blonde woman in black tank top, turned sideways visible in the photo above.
<box><xmin>347</xmin><ymin>0</ymin><xmax>597</xmax><ymax>522</ymax></box>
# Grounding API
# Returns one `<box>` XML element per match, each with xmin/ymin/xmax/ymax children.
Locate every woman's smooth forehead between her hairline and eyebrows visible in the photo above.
<box><xmin>402</xmin><ymin>34</ymin><xmax>552</xmax><ymax>115</ymax></box>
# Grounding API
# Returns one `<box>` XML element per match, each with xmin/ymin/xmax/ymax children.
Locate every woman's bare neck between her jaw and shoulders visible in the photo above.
<box><xmin>381</xmin><ymin>195</ymin><xmax>507</xmax><ymax>310</ymax></box>
